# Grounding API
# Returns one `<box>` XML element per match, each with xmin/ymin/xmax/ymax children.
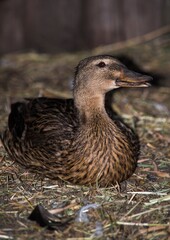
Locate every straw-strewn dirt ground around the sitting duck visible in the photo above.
<box><xmin>0</xmin><ymin>32</ymin><xmax>170</xmax><ymax>240</ymax></box>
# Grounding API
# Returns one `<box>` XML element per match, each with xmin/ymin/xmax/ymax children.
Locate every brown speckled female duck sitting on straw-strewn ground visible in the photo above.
<box><xmin>2</xmin><ymin>55</ymin><xmax>151</xmax><ymax>186</ymax></box>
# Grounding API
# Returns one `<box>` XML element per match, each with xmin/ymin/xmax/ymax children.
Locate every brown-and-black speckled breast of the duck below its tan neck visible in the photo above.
<box><xmin>63</xmin><ymin>111</ymin><xmax>139</xmax><ymax>186</ymax></box>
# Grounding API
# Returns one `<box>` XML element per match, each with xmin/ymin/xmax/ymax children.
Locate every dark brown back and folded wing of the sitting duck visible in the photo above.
<box><xmin>2</xmin><ymin>98</ymin><xmax>78</xmax><ymax>170</ymax></box>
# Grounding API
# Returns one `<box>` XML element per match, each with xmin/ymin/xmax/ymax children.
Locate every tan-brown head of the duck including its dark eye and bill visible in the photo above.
<box><xmin>74</xmin><ymin>55</ymin><xmax>152</xmax><ymax>94</ymax></box>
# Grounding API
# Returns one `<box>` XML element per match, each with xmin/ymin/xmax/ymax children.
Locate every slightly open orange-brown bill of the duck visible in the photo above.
<box><xmin>116</xmin><ymin>69</ymin><xmax>152</xmax><ymax>87</ymax></box>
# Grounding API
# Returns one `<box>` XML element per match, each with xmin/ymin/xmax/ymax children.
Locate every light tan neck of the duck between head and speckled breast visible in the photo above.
<box><xmin>74</xmin><ymin>90</ymin><xmax>107</xmax><ymax>124</ymax></box>
